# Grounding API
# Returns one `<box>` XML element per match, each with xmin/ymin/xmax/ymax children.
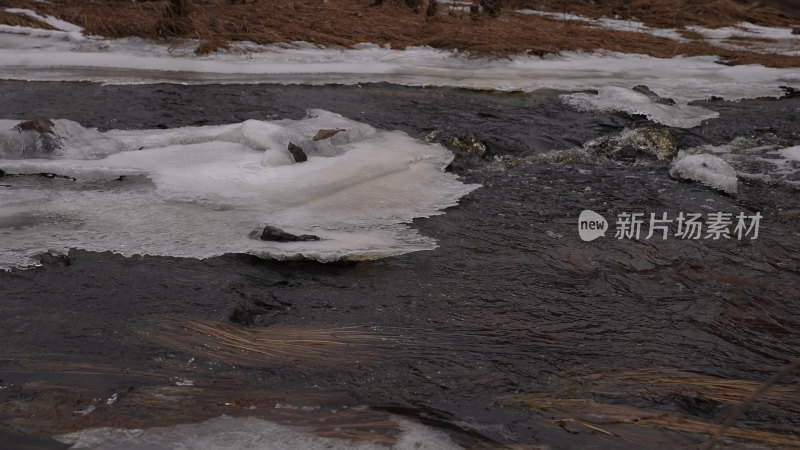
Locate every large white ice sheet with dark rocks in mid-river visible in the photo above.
<box><xmin>0</xmin><ymin>110</ymin><xmax>478</xmax><ymax>268</ymax></box>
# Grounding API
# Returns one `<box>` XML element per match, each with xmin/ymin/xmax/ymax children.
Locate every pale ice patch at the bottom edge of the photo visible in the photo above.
<box><xmin>56</xmin><ymin>416</ymin><xmax>461</xmax><ymax>450</ymax></box>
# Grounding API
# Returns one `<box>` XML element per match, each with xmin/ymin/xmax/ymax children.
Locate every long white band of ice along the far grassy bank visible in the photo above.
<box><xmin>0</xmin><ymin>10</ymin><xmax>800</xmax><ymax>128</ymax></box>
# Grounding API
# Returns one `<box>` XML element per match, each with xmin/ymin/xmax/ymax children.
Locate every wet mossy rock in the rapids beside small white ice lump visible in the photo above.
<box><xmin>584</xmin><ymin>128</ymin><xmax>678</xmax><ymax>161</ymax></box>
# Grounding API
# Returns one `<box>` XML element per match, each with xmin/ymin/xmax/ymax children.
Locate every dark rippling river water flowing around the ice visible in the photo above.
<box><xmin>0</xmin><ymin>82</ymin><xmax>800</xmax><ymax>448</ymax></box>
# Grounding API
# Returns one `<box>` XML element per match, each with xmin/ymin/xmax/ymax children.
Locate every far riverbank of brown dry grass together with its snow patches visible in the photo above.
<box><xmin>0</xmin><ymin>0</ymin><xmax>800</xmax><ymax>67</ymax></box>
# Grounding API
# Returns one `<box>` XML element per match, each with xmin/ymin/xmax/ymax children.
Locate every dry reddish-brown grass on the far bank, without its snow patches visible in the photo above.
<box><xmin>0</xmin><ymin>0</ymin><xmax>800</xmax><ymax>67</ymax></box>
